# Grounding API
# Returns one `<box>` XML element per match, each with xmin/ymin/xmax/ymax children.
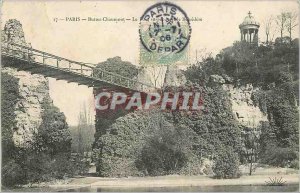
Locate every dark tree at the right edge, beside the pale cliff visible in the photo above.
<box><xmin>254</xmin><ymin>81</ymin><xmax>299</xmax><ymax>167</ymax></box>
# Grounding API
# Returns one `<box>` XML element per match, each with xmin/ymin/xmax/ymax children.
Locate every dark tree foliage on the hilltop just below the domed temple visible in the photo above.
<box><xmin>220</xmin><ymin>37</ymin><xmax>299</xmax><ymax>86</ymax></box>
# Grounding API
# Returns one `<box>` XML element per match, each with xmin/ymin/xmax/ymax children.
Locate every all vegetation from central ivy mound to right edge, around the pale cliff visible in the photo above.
<box><xmin>94</xmin><ymin>37</ymin><xmax>299</xmax><ymax>178</ymax></box>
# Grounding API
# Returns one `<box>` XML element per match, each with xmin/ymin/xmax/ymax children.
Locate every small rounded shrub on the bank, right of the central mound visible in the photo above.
<box><xmin>212</xmin><ymin>148</ymin><xmax>240</xmax><ymax>179</ymax></box>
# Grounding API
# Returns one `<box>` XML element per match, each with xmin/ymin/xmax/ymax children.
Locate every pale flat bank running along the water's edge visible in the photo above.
<box><xmin>3</xmin><ymin>167</ymin><xmax>299</xmax><ymax>192</ymax></box>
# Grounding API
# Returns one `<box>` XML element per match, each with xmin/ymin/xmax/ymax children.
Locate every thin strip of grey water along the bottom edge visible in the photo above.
<box><xmin>65</xmin><ymin>184</ymin><xmax>299</xmax><ymax>192</ymax></box>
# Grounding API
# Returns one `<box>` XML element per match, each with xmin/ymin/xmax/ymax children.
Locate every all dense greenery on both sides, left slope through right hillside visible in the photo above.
<box><xmin>1</xmin><ymin>35</ymin><xmax>299</xmax><ymax>186</ymax></box>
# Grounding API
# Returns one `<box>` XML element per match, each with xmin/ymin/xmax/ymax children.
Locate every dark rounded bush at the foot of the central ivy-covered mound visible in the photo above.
<box><xmin>136</xmin><ymin>120</ymin><xmax>191</xmax><ymax>175</ymax></box>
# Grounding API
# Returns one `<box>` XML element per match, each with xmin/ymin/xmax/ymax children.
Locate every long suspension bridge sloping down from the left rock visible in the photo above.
<box><xmin>1</xmin><ymin>42</ymin><xmax>156</xmax><ymax>93</ymax></box>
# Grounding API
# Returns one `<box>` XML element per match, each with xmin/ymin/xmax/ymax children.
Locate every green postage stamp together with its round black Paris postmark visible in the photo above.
<box><xmin>139</xmin><ymin>2</ymin><xmax>192</xmax><ymax>65</ymax></box>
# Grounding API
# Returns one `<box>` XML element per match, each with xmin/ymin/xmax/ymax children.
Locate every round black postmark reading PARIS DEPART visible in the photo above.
<box><xmin>139</xmin><ymin>2</ymin><xmax>192</xmax><ymax>54</ymax></box>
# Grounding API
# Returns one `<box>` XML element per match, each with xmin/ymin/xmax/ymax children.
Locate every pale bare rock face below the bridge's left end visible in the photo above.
<box><xmin>2</xmin><ymin>68</ymin><xmax>49</xmax><ymax>147</ymax></box>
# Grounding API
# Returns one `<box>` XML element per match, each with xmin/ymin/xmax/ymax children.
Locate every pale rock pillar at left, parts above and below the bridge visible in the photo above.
<box><xmin>1</xmin><ymin>19</ymin><xmax>50</xmax><ymax>147</ymax></box>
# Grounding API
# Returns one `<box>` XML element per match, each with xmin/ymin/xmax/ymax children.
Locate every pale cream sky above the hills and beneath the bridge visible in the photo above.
<box><xmin>1</xmin><ymin>0</ymin><xmax>299</xmax><ymax>125</ymax></box>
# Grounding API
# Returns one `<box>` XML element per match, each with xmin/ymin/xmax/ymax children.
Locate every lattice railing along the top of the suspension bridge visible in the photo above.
<box><xmin>1</xmin><ymin>42</ymin><xmax>156</xmax><ymax>91</ymax></box>
